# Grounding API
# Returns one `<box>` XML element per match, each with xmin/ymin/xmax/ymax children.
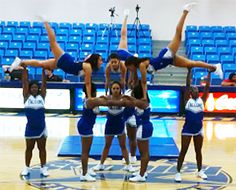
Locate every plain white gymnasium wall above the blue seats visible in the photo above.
<box><xmin>0</xmin><ymin>0</ymin><xmax>236</xmax><ymax>40</ymax></box>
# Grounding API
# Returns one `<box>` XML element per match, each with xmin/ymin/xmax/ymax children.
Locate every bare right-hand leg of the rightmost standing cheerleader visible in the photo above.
<box><xmin>193</xmin><ymin>135</ymin><xmax>203</xmax><ymax>171</ymax></box>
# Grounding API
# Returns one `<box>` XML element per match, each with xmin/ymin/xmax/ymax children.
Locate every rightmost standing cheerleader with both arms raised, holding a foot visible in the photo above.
<box><xmin>175</xmin><ymin>68</ymin><xmax>211</xmax><ymax>182</ymax></box>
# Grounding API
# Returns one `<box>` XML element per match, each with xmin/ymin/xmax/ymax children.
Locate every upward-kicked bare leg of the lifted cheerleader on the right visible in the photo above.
<box><xmin>168</xmin><ymin>10</ymin><xmax>188</xmax><ymax>54</ymax></box>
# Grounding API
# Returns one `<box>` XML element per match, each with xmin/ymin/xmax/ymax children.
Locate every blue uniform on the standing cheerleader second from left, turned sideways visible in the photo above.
<box><xmin>77</xmin><ymin>100</ymin><xmax>99</xmax><ymax>137</ymax></box>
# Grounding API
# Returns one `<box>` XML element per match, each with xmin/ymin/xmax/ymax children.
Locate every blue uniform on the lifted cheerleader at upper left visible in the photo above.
<box><xmin>57</xmin><ymin>53</ymin><xmax>84</xmax><ymax>76</ymax></box>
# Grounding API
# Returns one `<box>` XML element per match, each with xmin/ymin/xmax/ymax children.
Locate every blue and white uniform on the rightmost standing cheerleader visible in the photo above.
<box><xmin>182</xmin><ymin>98</ymin><xmax>204</xmax><ymax>136</ymax></box>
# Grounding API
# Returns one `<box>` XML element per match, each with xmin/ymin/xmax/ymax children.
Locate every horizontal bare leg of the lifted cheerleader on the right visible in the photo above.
<box><xmin>174</xmin><ymin>55</ymin><xmax>216</xmax><ymax>71</ymax></box>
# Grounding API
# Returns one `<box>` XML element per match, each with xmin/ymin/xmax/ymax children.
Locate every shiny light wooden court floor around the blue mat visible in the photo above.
<box><xmin>0</xmin><ymin>113</ymin><xmax>236</xmax><ymax>190</ymax></box>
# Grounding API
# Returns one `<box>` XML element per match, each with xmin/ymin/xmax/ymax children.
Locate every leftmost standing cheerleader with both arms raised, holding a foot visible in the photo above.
<box><xmin>21</xmin><ymin>67</ymin><xmax>49</xmax><ymax>176</ymax></box>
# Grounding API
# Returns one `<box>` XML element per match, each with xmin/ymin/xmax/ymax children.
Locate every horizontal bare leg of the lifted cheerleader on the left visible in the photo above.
<box><xmin>21</xmin><ymin>59</ymin><xmax>56</xmax><ymax>70</ymax></box>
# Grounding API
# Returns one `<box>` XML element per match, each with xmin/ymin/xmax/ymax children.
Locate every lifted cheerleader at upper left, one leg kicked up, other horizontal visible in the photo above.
<box><xmin>10</xmin><ymin>19</ymin><xmax>102</xmax><ymax>98</ymax></box>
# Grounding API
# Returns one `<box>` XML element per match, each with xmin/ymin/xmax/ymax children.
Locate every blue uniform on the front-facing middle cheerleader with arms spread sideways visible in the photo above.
<box><xmin>105</xmin><ymin>106</ymin><xmax>125</xmax><ymax>136</ymax></box>
